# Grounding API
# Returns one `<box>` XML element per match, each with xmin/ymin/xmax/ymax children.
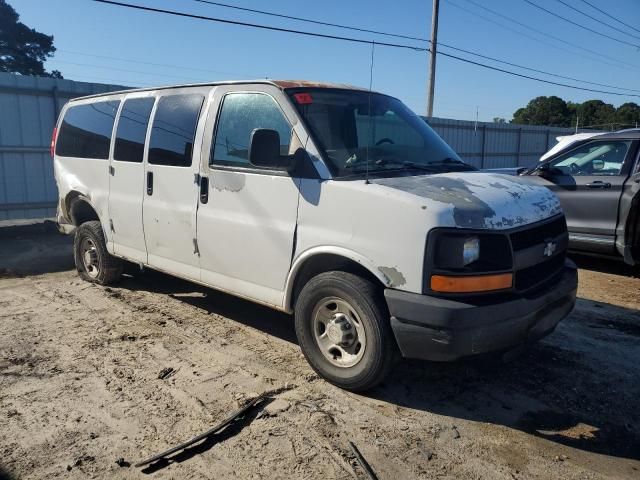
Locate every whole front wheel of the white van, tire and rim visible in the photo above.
<box><xmin>295</xmin><ymin>272</ymin><xmax>396</xmax><ymax>391</ymax></box>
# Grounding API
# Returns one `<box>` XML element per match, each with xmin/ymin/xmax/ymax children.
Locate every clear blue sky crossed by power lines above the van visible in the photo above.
<box><xmin>8</xmin><ymin>0</ymin><xmax>640</xmax><ymax>120</ymax></box>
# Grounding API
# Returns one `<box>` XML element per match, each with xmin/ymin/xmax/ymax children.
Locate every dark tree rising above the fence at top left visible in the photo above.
<box><xmin>0</xmin><ymin>0</ymin><xmax>62</xmax><ymax>78</ymax></box>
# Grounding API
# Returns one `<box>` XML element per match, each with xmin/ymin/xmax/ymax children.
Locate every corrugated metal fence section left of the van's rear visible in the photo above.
<box><xmin>0</xmin><ymin>73</ymin><xmax>124</xmax><ymax>221</ymax></box>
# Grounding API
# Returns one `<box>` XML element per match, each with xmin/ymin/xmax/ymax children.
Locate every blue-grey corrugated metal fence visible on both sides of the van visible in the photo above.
<box><xmin>0</xmin><ymin>73</ymin><xmax>600</xmax><ymax>221</ymax></box>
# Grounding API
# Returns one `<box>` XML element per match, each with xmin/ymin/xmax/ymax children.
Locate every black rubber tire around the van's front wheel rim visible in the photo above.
<box><xmin>295</xmin><ymin>271</ymin><xmax>398</xmax><ymax>391</ymax></box>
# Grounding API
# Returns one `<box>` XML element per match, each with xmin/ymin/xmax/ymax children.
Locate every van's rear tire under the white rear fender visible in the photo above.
<box><xmin>73</xmin><ymin>220</ymin><xmax>123</xmax><ymax>285</ymax></box>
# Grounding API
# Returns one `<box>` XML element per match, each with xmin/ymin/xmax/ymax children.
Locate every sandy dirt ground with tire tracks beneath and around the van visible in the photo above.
<box><xmin>0</xmin><ymin>233</ymin><xmax>640</xmax><ymax>480</ymax></box>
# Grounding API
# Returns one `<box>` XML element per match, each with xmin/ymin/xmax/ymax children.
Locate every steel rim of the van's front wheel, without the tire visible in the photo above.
<box><xmin>311</xmin><ymin>297</ymin><xmax>367</xmax><ymax>368</ymax></box>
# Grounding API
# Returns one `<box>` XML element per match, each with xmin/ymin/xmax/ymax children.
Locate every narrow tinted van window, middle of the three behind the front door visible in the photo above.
<box><xmin>113</xmin><ymin>98</ymin><xmax>155</xmax><ymax>163</ymax></box>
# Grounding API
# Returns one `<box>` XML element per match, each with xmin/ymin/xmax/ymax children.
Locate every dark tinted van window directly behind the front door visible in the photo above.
<box><xmin>149</xmin><ymin>94</ymin><xmax>204</xmax><ymax>167</ymax></box>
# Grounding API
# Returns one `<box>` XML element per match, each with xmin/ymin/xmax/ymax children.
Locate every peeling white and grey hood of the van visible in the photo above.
<box><xmin>370</xmin><ymin>172</ymin><xmax>562</xmax><ymax>230</ymax></box>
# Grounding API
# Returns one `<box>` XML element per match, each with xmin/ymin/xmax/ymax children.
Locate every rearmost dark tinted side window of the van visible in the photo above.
<box><xmin>56</xmin><ymin>101</ymin><xmax>120</xmax><ymax>160</ymax></box>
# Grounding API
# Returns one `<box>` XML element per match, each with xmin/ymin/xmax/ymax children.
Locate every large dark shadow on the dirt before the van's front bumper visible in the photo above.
<box><xmin>372</xmin><ymin>341</ymin><xmax>640</xmax><ymax>460</ymax></box>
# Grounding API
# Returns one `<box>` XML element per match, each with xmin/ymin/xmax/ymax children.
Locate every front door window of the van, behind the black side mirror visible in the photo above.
<box><xmin>210</xmin><ymin>93</ymin><xmax>291</xmax><ymax>167</ymax></box>
